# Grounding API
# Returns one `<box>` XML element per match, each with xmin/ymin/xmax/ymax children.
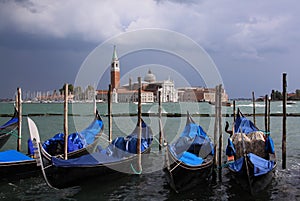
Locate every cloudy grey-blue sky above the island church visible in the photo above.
<box><xmin>0</xmin><ymin>0</ymin><xmax>300</xmax><ymax>98</ymax></box>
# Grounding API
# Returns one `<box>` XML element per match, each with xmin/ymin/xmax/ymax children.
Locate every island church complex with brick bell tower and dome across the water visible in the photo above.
<box><xmin>96</xmin><ymin>46</ymin><xmax>228</xmax><ymax>103</ymax></box>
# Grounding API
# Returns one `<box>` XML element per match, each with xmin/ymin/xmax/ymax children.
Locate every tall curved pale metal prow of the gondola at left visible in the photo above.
<box><xmin>27</xmin><ymin>117</ymin><xmax>57</xmax><ymax>189</ymax></box>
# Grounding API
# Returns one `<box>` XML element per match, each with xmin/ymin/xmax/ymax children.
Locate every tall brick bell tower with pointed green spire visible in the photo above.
<box><xmin>110</xmin><ymin>45</ymin><xmax>120</xmax><ymax>89</ymax></box>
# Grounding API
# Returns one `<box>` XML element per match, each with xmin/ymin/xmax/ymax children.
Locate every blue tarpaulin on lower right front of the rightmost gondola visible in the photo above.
<box><xmin>248</xmin><ymin>153</ymin><xmax>274</xmax><ymax>176</ymax></box>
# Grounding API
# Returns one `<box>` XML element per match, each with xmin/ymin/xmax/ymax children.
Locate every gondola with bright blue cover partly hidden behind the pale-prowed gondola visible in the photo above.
<box><xmin>0</xmin><ymin>110</ymin><xmax>103</xmax><ymax>180</ymax></box>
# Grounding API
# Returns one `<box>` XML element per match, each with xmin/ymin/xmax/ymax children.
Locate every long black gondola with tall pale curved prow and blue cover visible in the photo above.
<box><xmin>28</xmin><ymin>118</ymin><xmax>153</xmax><ymax>188</ymax></box>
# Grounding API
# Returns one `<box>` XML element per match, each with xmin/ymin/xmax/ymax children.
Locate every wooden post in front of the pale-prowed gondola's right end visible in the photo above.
<box><xmin>136</xmin><ymin>77</ymin><xmax>142</xmax><ymax>172</ymax></box>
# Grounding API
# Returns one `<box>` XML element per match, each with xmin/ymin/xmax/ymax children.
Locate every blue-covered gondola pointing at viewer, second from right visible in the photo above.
<box><xmin>164</xmin><ymin>113</ymin><xmax>214</xmax><ymax>192</ymax></box>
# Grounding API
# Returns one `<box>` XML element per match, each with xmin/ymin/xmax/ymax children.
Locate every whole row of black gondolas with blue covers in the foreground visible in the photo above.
<box><xmin>0</xmin><ymin>106</ymin><xmax>276</xmax><ymax>193</ymax></box>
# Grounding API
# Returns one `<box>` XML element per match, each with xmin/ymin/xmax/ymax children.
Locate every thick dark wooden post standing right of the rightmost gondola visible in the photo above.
<box><xmin>282</xmin><ymin>73</ymin><xmax>287</xmax><ymax>169</ymax></box>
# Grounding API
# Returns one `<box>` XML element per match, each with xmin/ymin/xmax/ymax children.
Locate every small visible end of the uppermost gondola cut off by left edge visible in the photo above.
<box><xmin>0</xmin><ymin>108</ymin><xmax>19</xmax><ymax>149</ymax></box>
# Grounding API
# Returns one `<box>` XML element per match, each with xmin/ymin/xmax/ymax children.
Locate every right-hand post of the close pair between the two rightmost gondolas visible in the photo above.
<box><xmin>218</xmin><ymin>84</ymin><xmax>223</xmax><ymax>181</ymax></box>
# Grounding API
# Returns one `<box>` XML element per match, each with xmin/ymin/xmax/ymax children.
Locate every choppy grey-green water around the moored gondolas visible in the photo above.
<box><xmin>0</xmin><ymin>101</ymin><xmax>300</xmax><ymax>201</ymax></box>
